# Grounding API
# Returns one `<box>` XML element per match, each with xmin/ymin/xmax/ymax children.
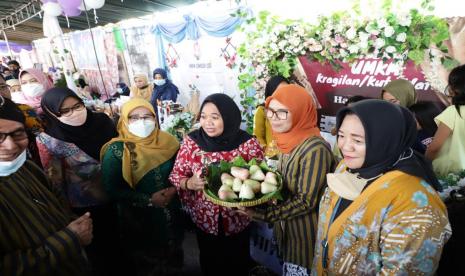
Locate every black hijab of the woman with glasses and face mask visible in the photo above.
<box><xmin>40</xmin><ymin>88</ymin><xmax>118</xmax><ymax>161</ymax></box>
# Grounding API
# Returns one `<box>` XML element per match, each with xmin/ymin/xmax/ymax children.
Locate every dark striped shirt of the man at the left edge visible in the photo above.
<box><xmin>0</xmin><ymin>161</ymin><xmax>87</xmax><ymax>276</ymax></box>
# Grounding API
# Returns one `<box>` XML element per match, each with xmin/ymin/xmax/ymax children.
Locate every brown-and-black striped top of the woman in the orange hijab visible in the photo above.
<box><xmin>262</xmin><ymin>137</ymin><xmax>335</xmax><ymax>269</ymax></box>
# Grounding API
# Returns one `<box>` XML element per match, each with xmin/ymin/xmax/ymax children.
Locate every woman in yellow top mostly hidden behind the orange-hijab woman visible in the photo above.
<box><xmin>253</xmin><ymin>75</ymin><xmax>289</xmax><ymax>157</ymax></box>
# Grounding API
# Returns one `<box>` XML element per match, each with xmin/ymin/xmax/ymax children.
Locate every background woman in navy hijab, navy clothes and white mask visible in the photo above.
<box><xmin>150</xmin><ymin>68</ymin><xmax>179</xmax><ymax>107</ymax></box>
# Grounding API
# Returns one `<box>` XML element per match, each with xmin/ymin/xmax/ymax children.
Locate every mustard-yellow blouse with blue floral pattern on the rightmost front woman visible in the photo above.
<box><xmin>312</xmin><ymin>165</ymin><xmax>452</xmax><ymax>275</ymax></box>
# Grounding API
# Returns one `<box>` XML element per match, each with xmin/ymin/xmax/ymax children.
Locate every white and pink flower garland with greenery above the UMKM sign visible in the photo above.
<box><xmin>238</xmin><ymin>0</ymin><xmax>457</xmax><ymax>134</ymax></box>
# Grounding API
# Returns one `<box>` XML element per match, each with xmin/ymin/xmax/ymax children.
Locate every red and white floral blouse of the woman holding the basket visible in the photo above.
<box><xmin>169</xmin><ymin>136</ymin><xmax>263</xmax><ymax>235</ymax></box>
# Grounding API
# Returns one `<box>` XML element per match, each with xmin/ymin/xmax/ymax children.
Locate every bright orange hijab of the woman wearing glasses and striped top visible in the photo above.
<box><xmin>265</xmin><ymin>84</ymin><xmax>320</xmax><ymax>153</ymax></box>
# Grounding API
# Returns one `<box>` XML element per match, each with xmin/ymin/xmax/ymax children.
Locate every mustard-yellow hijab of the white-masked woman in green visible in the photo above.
<box><xmin>100</xmin><ymin>98</ymin><xmax>179</xmax><ymax>188</ymax></box>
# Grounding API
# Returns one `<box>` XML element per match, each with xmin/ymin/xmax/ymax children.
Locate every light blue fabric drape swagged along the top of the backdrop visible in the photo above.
<box><xmin>152</xmin><ymin>8</ymin><xmax>252</xmax><ymax>70</ymax></box>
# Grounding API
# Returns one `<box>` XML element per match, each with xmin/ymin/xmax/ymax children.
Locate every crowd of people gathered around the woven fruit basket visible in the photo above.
<box><xmin>0</xmin><ymin>56</ymin><xmax>465</xmax><ymax>276</ymax></box>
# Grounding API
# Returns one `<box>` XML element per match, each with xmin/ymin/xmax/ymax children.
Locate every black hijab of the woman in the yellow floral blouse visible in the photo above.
<box><xmin>336</xmin><ymin>100</ymin><xmax>440</xmax><ymax>190</ymax></box>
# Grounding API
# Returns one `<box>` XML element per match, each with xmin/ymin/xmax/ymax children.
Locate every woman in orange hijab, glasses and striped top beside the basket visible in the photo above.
<box><xmin>239</xmin><ymin>84</ymin><xmax>335</xmax><ymax>275</ymax></box>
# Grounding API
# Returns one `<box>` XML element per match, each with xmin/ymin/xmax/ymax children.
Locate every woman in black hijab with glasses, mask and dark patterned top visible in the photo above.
<box><xmin>36</xmin><ymin>88</ymin><xmax>117</xmax><ymax>273</ymax></box>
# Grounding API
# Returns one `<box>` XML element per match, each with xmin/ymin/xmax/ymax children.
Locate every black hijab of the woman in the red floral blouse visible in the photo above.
<box><xmin>189</xmin><ymin>93</ymin><xmax>252</xmax><ymax>152</ymax></box>
